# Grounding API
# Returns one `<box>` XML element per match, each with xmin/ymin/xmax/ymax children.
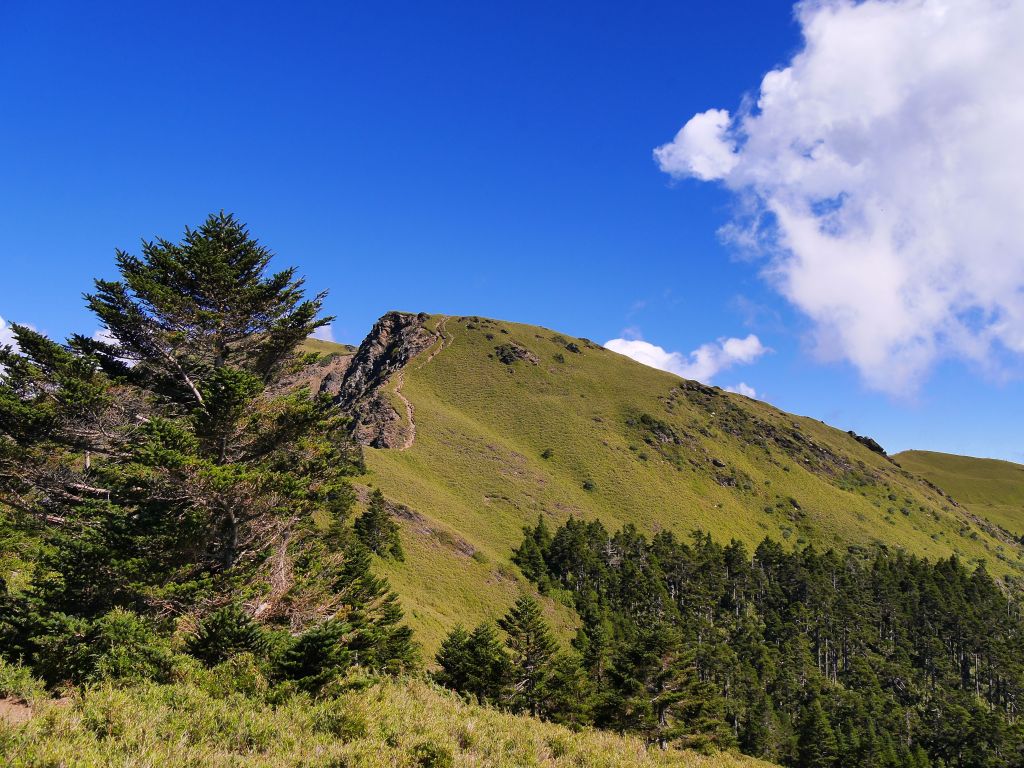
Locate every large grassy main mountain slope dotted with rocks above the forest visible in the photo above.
<box><xmin>329</xmin><ymin>315</ymin><xmax>1021</xmax><ymax>652</ymax></box>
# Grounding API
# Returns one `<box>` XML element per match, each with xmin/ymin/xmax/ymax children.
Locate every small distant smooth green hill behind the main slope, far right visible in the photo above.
<box><xmin>894</xmin><ymin>451</ymin><xmax>1024</xmax><ymax>536</ymax></box>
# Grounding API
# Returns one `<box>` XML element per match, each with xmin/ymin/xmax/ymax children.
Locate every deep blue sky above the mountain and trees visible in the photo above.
<box><xmin>0</xmin><ymin>0</ymin><xmax>1024</xmax><ymax>461</ymax></box>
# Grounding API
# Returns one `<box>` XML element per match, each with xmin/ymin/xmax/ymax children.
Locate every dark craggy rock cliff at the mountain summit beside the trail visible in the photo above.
<box><xmin>322</xmin><ymin>312</ymin><xmax>439</xmax><ymax>449</ymax></box>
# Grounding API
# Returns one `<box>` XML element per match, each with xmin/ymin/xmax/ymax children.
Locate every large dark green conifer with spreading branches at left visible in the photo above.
<box><xmin>0</xmin><ymin>213</ymin><xmax>415</xmax><ymax>684</ymax></box>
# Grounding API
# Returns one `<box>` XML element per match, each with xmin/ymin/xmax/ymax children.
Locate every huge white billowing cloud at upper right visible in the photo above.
<box><xmin>654</xmin><ymin>0</ymin><xmax>1024</xmax><ymax>393</ymax></box>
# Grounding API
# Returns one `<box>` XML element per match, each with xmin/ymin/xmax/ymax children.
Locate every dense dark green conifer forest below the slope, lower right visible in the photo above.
<box><xmin>513</xmin><ymin>518</ymin><xmax>1024</xmax><ymax>768</ymax></box>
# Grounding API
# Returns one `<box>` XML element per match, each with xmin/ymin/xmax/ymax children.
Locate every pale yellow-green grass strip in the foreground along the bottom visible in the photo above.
<box><xmin>0</xmin><ymin>680</ymin><xmax>768</xmax><ymax>768</ymax></box>
